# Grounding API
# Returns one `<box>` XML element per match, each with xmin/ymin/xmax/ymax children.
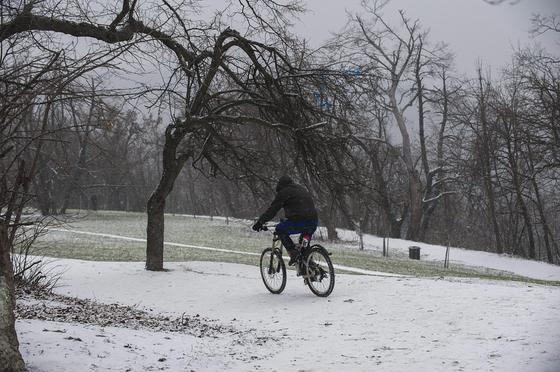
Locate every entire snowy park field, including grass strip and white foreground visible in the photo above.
<box><xmin>12</xmin><ymin>212</ymin><xmax>560</xmax><ymax>372</ymax></box>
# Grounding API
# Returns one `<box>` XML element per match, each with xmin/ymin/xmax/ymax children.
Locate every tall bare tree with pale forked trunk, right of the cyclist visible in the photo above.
<box><xmin>330</xmin><ymin>1</ymin><xmax>452</xmax><ymax>240</ymax></box>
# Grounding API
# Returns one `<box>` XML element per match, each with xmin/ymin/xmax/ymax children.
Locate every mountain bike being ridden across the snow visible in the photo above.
<box><xmin>260</xmin><ymin>225</ymin><xmax>334</xmax><ymax>297</ymax></box>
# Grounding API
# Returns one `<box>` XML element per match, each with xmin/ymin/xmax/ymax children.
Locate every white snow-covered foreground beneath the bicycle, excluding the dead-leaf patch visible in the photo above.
<box><xmin>16</xmin><ymin>258</ymin><xmax>560</xmax><ymax>372</ymax></box>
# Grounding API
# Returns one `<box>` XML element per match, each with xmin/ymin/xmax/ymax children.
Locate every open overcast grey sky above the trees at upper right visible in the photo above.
<box><xmin>294</xmin><ymin>0</ymin><xmax>560</xmax><ymax>75</ymax></box>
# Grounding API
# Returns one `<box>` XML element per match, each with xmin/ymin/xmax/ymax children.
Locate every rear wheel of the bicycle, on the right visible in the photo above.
<box><xmin>304</xmin><ymin>245</ymin><xmax>334</xmax><ymax>297</ymax></box>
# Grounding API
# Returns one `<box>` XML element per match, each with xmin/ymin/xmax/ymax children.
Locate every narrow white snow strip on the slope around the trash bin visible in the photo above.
<box><xmin>330</xmin><ymin>229</ymin><xmax>560</xmax><ymax>281</ymax></box>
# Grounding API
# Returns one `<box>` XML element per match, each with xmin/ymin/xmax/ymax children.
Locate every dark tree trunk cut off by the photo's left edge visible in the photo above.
<box><xmin>0</xmin><ymin>44</ymin><xmax>60</xmax><ymax>371</ymax></box>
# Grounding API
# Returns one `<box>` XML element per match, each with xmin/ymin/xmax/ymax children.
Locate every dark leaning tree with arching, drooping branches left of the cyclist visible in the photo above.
<box><xmin>0</xmin><ymin>0</ymin><xmax>328</xmax><ymax>270</ymax></box>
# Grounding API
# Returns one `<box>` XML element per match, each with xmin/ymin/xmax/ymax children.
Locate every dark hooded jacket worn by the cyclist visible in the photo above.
<box><xmin>259</xmin><ymin>176</ymin><xmax>317</xmax><ymax>223</ymax></box>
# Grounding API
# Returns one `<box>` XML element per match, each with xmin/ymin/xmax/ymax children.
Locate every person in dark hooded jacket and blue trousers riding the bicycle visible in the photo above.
<box><xmin>253</xmin><ymin>176</ymin><xmax>318</xmax><ymax>265</ymax></box>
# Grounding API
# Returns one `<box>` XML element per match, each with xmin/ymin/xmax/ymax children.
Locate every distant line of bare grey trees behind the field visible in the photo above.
<box><xmin>2</xmin><ymin>2</ymin><xmax>560</xmax><ymax>263</ymax></box>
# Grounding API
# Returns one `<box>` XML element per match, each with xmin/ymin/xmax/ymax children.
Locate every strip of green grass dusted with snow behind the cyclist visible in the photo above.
<box><xmin>34</xmin><ymin>211</ymin><xmax>558</xmax><ymax>284</ymax></box>
